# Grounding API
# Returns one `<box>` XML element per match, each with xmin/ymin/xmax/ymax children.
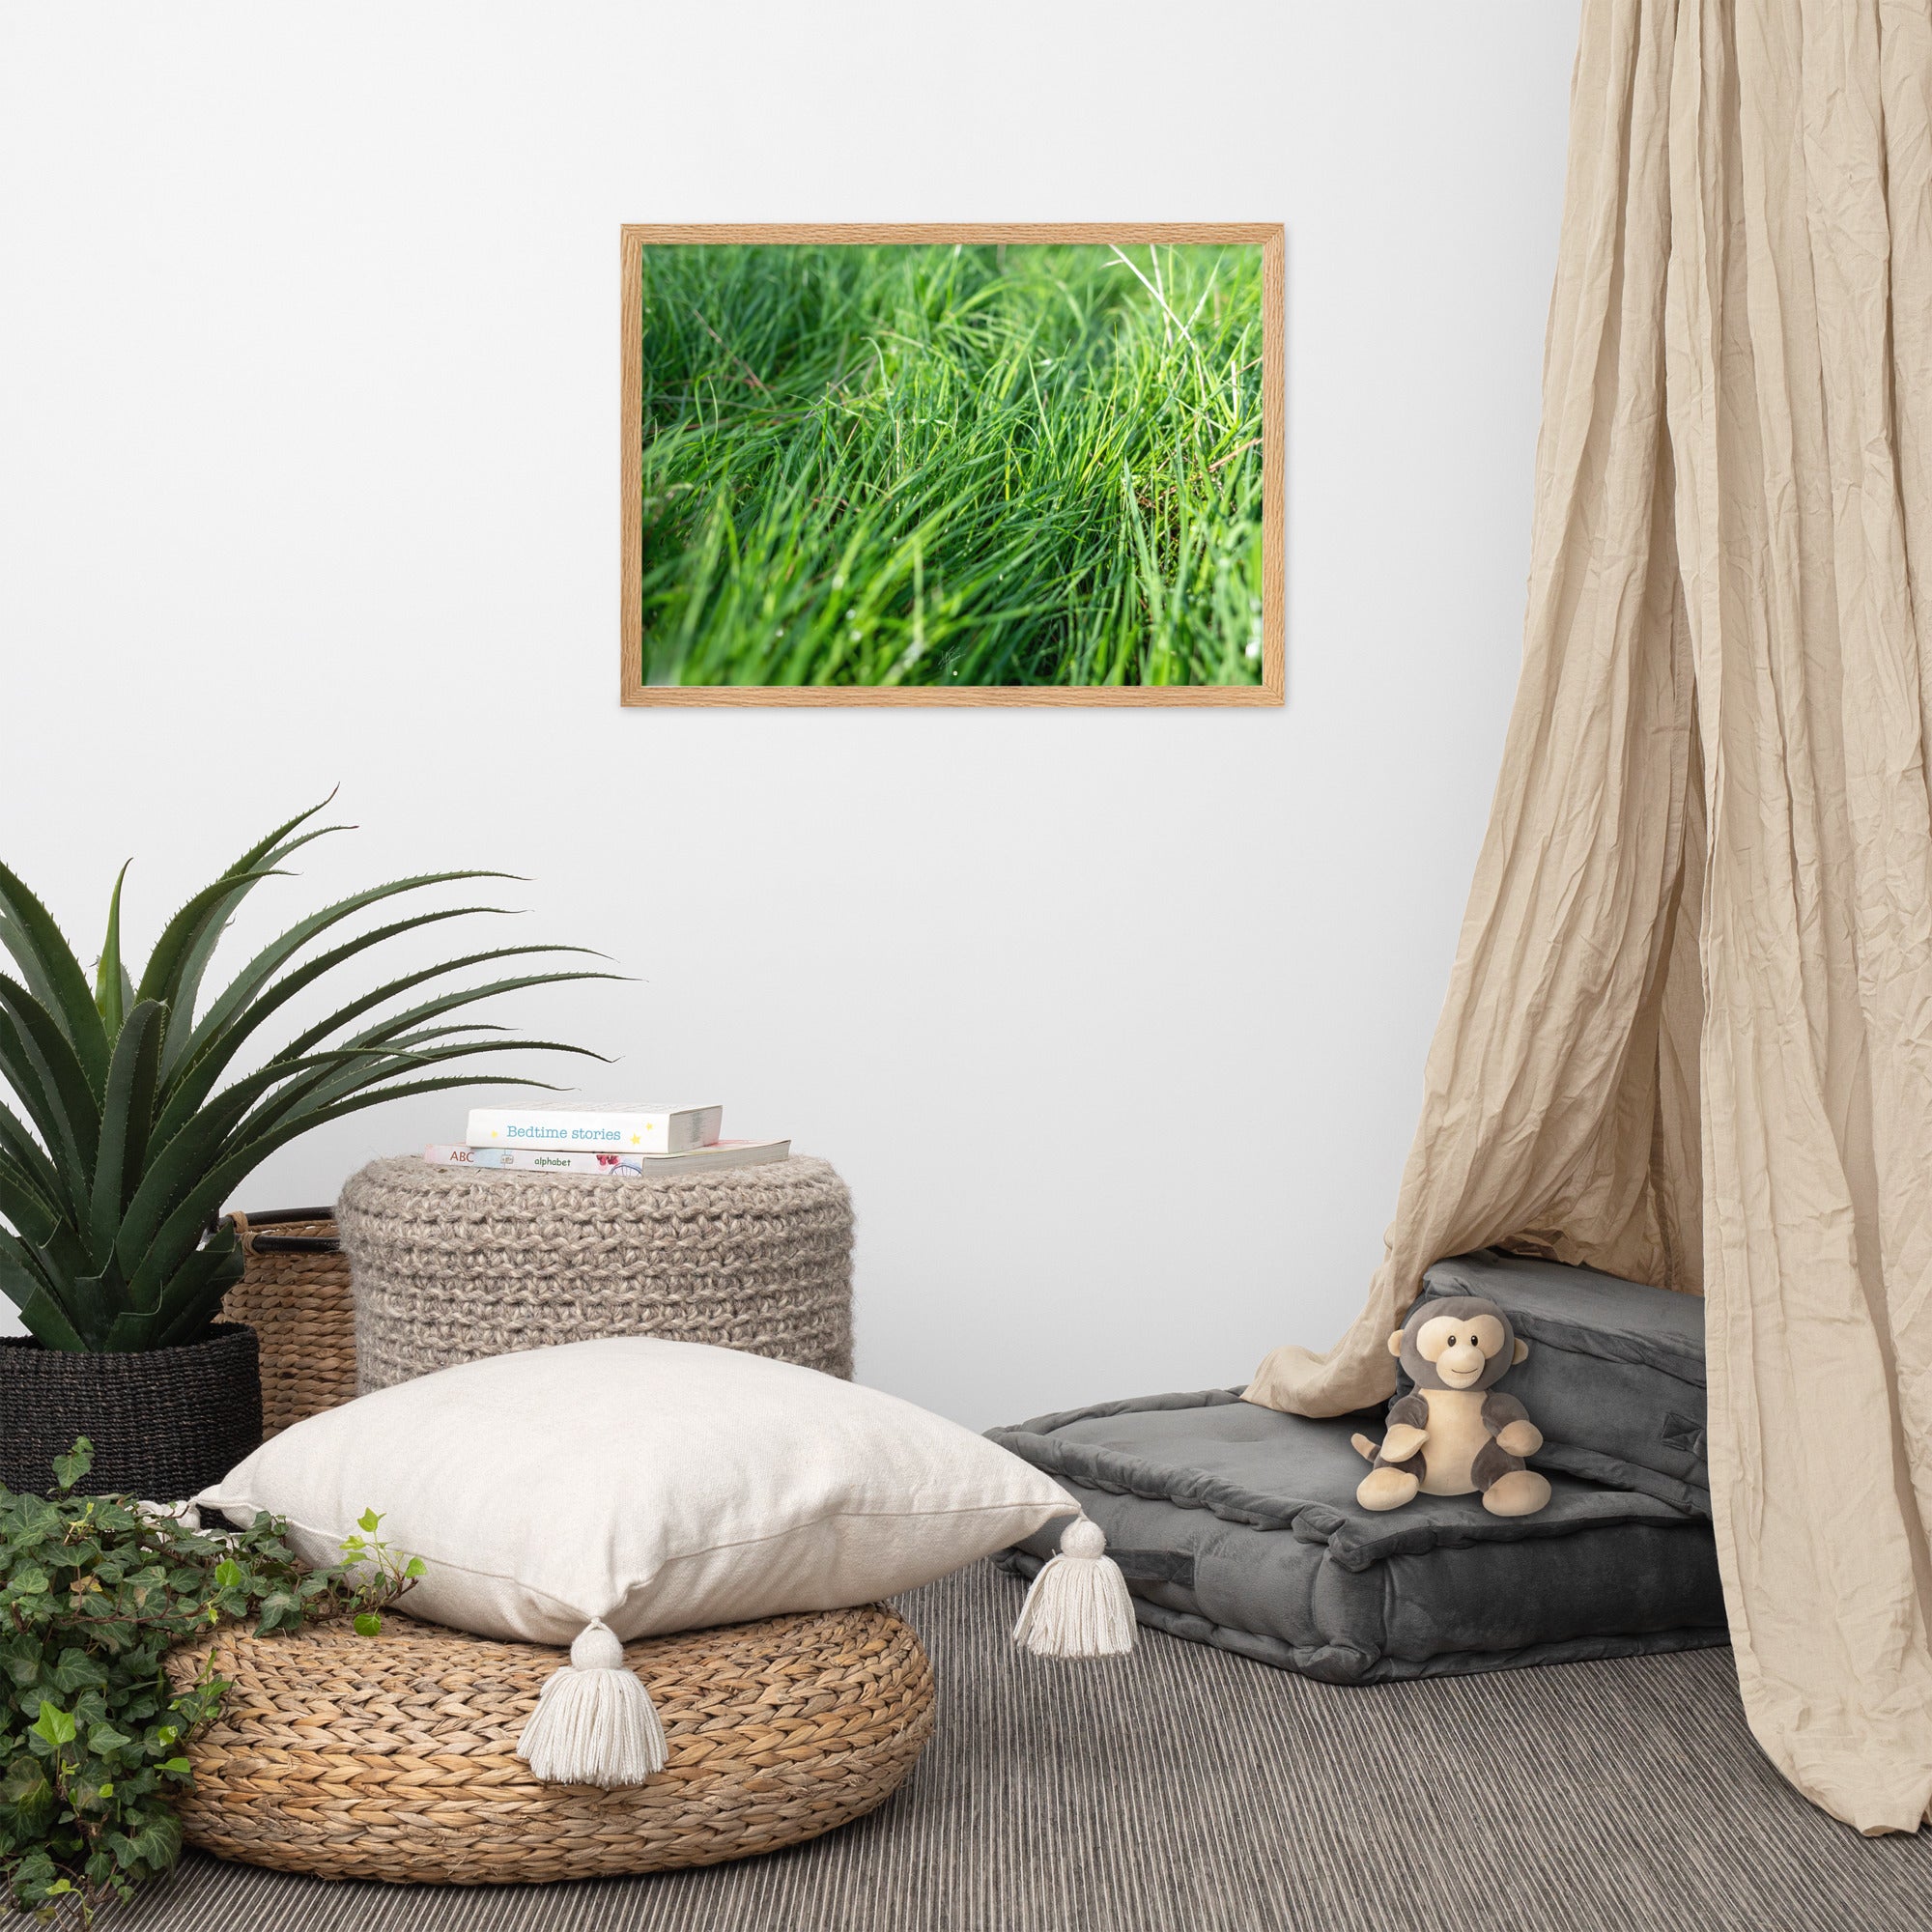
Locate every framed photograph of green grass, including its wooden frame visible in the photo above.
<box><xmin>622</xmin><ymin>222</ymin><xmax>1285</xmax><ymax>705</ymax></box>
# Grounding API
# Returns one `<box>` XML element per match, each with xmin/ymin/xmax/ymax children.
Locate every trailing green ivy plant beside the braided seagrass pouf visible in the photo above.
<box><xmin>0</xmin><ymin>1437</ymin><xmax>423</xmax><ymax>1926</ymax></box>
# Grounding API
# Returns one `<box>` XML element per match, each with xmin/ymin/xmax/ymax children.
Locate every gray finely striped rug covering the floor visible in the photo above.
<box><xmin>128</xmin><ymin>1567</ymin><xmax>1932</xmax><ymax>1932</ymax></box>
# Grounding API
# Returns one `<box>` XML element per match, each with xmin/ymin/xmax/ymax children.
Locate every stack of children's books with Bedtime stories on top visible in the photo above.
<box><xmin>423</xmin><ymin>1107</ymin><xmax>792</xmax><ymax>1175</ymax></box>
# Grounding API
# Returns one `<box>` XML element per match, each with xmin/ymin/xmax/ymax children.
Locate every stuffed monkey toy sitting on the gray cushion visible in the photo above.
<box><xmin>1354</xmin><ymin>1294</ymin><xmax>1549</xmax><ymax>1517</ymax></box>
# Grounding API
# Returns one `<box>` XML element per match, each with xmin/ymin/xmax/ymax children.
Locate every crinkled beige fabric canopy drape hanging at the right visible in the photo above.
<box><xmin>1248</xmin><ymin>0</ymin><xmax>1932</xmax><ymax>1832</ymax></box>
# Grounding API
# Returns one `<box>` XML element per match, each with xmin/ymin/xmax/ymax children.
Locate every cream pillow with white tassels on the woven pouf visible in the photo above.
<box><xmin>195</xmin><ymin>1337</ymin><xmax>1132</xmax><ymax>1783</ymax></box>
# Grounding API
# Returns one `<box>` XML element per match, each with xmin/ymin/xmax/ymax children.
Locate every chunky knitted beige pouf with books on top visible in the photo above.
<box><xmin>336</xmin><ymin>1157</ymin><xmax>852</xmax><ymax>1393</ymax></box>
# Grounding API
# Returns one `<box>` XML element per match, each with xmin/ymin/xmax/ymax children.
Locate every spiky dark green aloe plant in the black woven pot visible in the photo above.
<box><xmin>0</xmin><ymin>800</ymin><xmax>616</xmax><ymax>1352</ymax></box>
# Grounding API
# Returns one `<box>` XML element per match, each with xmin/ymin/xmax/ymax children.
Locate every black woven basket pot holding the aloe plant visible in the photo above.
<box><xmin>0</xmin><ymin>1321</ymin><xmax>261</xmax><ymax>1503</ymax></box>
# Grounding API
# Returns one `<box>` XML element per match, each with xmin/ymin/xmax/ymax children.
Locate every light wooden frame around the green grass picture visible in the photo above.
<box><xmin>618</xmin><ymin>222</ymin><xmax>1287</xmax><ymax>707</ymax></box>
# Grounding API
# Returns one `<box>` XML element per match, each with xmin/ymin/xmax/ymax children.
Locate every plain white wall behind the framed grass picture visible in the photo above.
<box><xmin>0</xmin><ymin>0</ymin><xmax>1577</xmax><ymax>1424</ymax></box>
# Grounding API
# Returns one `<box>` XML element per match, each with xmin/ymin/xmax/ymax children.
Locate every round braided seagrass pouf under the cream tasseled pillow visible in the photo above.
<box><xmin>168</xmin><ymin>1604</ymin><xmax>933</xmax><ymax>1886</ymax></box>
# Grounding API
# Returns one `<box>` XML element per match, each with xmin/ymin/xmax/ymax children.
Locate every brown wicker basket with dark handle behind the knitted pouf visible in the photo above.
<box><xmin>222</xmin><ymin>1208</ymin><xmax>355</xmax><ymax>1439</ymax></box>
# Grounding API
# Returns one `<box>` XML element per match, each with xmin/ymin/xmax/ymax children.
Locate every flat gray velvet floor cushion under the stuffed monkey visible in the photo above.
<box><xmin>989</xmin><ymin>1389</ymin><xmax>1727</xmax><ymax>1683</ymax></box>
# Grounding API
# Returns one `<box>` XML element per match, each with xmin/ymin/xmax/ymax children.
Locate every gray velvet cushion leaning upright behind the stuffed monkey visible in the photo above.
<box><xmin>1422</xmin><ymin>1248</ymin><xmax>1710</xmax><ymax>1517</ymax></box>
